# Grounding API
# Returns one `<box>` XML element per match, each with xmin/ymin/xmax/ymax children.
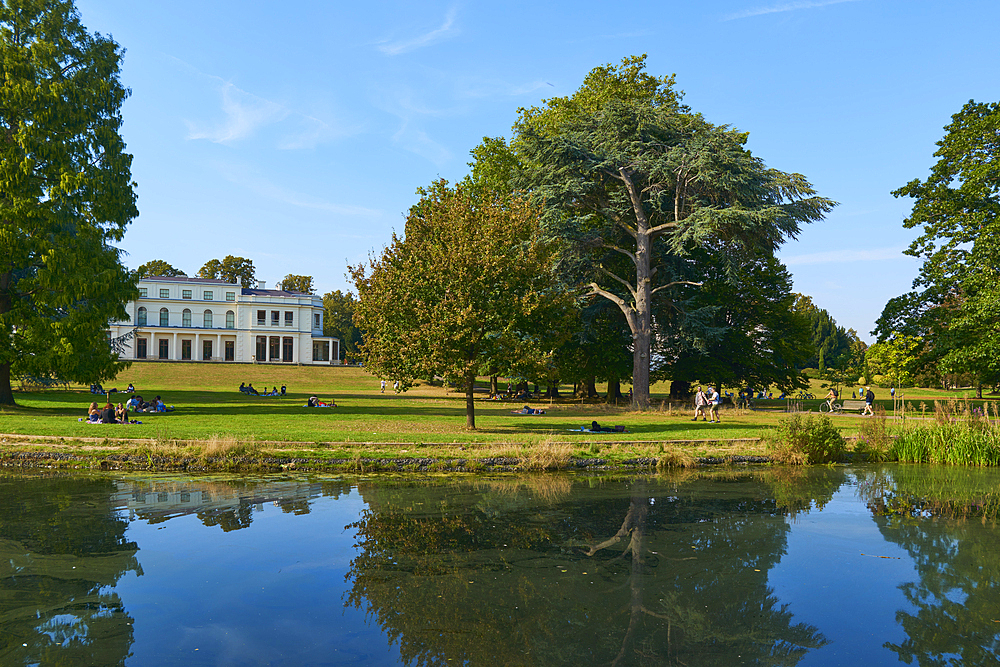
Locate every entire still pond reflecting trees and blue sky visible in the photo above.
<box><xmin>0</xmin><ymin>466</ymin><xmax>1000</xmax><ymax>667</ymax></box>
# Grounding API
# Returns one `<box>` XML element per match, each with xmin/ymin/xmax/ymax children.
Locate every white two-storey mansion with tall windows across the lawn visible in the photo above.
<box><xmin>109</xmin><ymin>276</ymin><xmax>340</xmax><ymax>365</ymax></box>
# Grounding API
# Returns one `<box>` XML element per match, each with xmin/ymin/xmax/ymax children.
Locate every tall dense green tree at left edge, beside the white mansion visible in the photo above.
<box><xmin>0</xmin><ymin>0</ymin><xmax>138</xmax><ymax>405</ymax></box>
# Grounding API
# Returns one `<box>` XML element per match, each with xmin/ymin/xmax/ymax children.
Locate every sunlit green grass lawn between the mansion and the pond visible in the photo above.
<box><xmin>0</xmin><ymin>362</ymin><xmax>992</xmax><ymax>464</ymax></box>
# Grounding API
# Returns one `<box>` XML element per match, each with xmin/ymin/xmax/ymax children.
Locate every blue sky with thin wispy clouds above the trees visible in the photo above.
<box><xmin>77</xmin><ymin>0</ymin><xmax>1000</xmax><ymax>340</ymax></box>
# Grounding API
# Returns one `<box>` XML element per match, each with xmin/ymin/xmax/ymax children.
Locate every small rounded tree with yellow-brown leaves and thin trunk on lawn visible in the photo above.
<box><xmin>350</xmin><ymin>181</ymin><xmax>565</xmax><ymax>428</ymax></box>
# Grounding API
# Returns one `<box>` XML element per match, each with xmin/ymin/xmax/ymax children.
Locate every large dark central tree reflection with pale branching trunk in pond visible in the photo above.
<box><xmin>347</xmin><ymin>474</ymin><xmax>825</xmax><ymax>665</ymax></box>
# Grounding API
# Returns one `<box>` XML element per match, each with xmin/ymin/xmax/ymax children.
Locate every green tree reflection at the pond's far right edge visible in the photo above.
<box><xmin>859</xmin><ymin>466</ymin><xmax>1000</xmax><ymax>667</ymax></box>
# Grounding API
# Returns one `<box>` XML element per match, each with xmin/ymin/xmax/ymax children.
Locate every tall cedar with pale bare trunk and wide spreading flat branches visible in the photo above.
<box><xmin>513</xmin><ymin>56</ymin><xmax>834</xmax><ymax>407</ymax></box>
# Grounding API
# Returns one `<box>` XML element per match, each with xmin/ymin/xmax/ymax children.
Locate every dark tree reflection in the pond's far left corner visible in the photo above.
<box><xmin>0</xmin><ymin>475</ymin><xmax>142</xmax><ymax>665</ymax></box>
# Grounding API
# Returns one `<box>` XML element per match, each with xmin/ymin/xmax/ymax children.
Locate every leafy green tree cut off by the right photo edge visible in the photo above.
<box><xmin>873</xmin><ymin>101</ymin><xmax>1000</xmax><ymax>394</ymax></box>
